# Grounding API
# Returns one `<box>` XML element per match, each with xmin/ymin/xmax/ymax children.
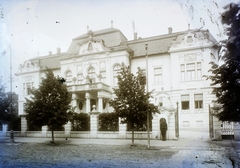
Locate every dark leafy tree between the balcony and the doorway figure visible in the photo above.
<box><xmin>110</xmin><ymin>64</ymin><xmax>157</xmax><ymax>144</ymax></box>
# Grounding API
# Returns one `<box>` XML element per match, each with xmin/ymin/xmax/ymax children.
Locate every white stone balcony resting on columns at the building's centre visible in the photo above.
<box><xmin>67</xmin><ymin>82</ymin><xmax>111</xmax><ymax>92</ymax></box>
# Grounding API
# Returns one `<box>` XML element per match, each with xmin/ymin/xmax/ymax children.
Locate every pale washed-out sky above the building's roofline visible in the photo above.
<box><xmin>0</xmin><ymin>0</ymin><xmax>239</xmax><ymax>92</ymax></box>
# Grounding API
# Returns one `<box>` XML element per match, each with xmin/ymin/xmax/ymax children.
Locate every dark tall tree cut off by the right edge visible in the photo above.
<box><xmin>207</xmin><ymin>3</ymin><xmax>240</xmax><ymax>122</ymax></box>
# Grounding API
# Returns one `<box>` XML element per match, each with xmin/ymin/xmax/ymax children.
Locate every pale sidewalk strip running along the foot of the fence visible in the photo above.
<box><xmin>0</xmin><ymin>137</ymin><xmax>240</xmax><ymax>152</ymax></box>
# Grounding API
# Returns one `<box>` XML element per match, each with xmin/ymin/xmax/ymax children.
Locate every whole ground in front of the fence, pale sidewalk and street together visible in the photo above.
<box><xmin>0</xmin><ymin>138</ymin><xmax>237</xmax><ymax>168</ymax></box>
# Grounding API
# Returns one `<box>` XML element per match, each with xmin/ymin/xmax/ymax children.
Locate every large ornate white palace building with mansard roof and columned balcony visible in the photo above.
<box><xmin>17</xmin><ymin>27</ymin><xmax>219</xmax><ymax>139</ymax></box>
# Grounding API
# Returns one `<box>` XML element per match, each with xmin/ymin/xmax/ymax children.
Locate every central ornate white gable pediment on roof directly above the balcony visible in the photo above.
<box><xmin>78</xmin><ymin>36</ymin><xmax>108</xmax><ymax>55</ymax></box>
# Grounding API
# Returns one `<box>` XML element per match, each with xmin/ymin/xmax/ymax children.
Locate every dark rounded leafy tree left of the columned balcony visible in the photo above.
<box><xmin>25</xmin><ymin>69</ymin><xmax>71</xmax><ymax>143</ymax></box>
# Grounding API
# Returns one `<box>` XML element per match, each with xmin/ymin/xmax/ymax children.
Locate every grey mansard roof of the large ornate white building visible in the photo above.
<box><xmin>21</xmin><ymin>28</ymin><xmax>217</xmax><ymax>69</ymax></box>
